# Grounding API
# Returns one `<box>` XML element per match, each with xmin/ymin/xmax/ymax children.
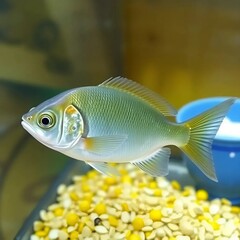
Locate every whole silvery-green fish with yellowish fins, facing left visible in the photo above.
<box><xmin>21</xmin><ymin>77</ymin><xmax>235</xmax><ymax>181</ymax></box>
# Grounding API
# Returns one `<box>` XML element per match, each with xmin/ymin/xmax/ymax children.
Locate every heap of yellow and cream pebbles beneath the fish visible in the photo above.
<box><xmin>31</xmin><ymin>164</ymin><xmax>240</xmax><ymax>240</ymax></box>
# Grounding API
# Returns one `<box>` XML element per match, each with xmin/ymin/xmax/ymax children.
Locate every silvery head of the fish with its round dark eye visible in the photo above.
<box><xmin>22</xmin><ymin>94</ymin><xmax>84</xmax><ymax>151</ymax></box>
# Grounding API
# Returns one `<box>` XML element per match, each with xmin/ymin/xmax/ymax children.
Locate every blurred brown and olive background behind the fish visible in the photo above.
<box><xmin>0</xmin><ymin>0</ymin><xmax>240</xmax><ymax>240</ymax></box>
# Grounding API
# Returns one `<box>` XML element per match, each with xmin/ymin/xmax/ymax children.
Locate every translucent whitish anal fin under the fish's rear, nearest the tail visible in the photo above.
<box><xmin>133</xmin><ymin>147</ymin><xmax>171</xmax><ymax>177</ymax></box>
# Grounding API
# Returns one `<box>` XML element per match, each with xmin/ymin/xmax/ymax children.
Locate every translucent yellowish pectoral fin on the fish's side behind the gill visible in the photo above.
<box><xmin>83</xmin><ymin>135</ymin><xmax>127</xmax><ymax>155</ymax></box>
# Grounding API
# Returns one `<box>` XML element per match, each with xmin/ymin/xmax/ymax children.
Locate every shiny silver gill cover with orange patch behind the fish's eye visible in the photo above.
<box><xmin>59</xmin><ymin>105</ymin><xmax>84</xmax><ymax>148</ymax></box>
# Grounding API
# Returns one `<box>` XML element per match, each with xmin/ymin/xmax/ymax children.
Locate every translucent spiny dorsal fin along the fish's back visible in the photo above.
<box><xmin>99</xmin><ymin>77</ymin><xmax>177</xmax><ymax>116</ymax></box>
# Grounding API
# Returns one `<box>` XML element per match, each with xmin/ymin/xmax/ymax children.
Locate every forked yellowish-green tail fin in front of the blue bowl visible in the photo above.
<box><xmin>180</xmin><ymin>98</ymin><xmax>235</xmax><ymax>182</ymax></box>
